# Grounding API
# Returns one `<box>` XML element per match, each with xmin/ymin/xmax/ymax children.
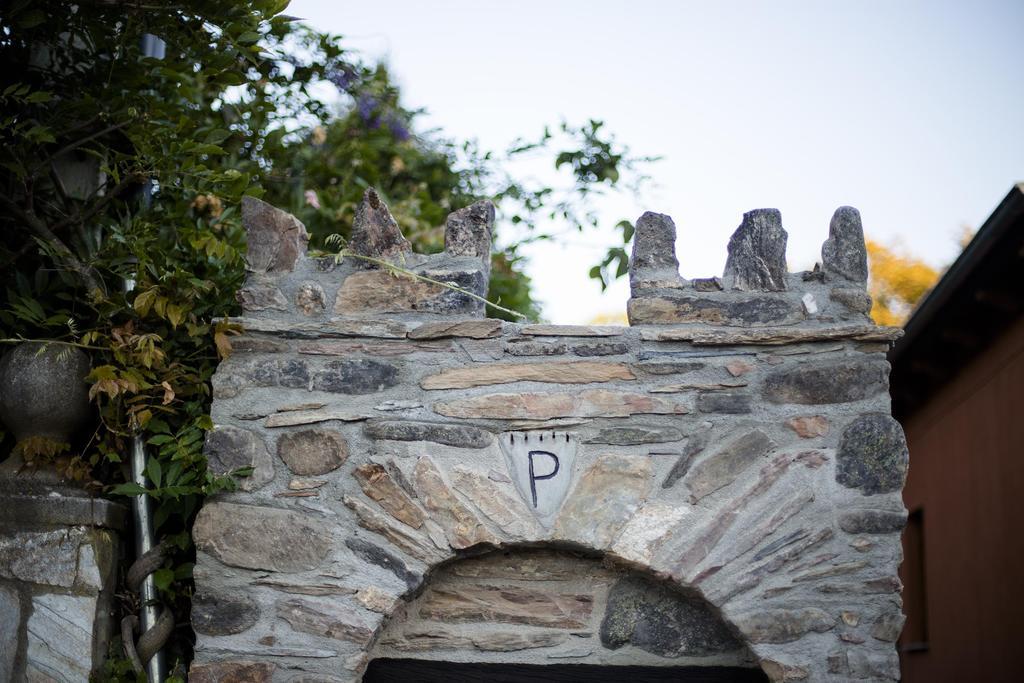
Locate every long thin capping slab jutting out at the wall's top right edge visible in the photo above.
<box><xmin>639</xmin><ymin>325</ymin><xmax>903</xmax><ymax>346</ymax></box>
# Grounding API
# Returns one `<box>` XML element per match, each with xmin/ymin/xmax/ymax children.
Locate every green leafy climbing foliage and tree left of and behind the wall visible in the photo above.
<box><xmin>0</xmin><ymin>0</ymin><xmax>643</xmax><ymax>678</ymax></box>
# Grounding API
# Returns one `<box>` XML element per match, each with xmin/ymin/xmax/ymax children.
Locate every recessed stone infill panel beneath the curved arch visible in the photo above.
<box><xmin>370</xmin><ymin>547</ymin><xmax>767</xmax><ymax>680</ymax></box>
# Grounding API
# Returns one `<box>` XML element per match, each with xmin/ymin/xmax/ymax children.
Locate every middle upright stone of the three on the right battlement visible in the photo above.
<box><xmin>722</xmin><ymin>209</ymin><xmax>787</xmax><ymax>292</ymax></box>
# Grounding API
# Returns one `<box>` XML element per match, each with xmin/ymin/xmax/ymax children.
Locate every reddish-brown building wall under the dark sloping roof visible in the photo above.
<box><xmin>901</xmin><ymin>319</ymin><xmax>1024</xmax><ymax>683</ymax></box>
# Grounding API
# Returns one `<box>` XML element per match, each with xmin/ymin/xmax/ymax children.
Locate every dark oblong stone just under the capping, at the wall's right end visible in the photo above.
<box><xmin>762</xmin><ymin>360</ymin><xmax>889</xmax><ymax>405</ymax></box>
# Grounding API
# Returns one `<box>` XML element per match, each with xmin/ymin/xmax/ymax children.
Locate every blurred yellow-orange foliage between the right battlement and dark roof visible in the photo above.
<box><xmin>866</xmin><ymin>240</ymin><xmax>940</xmax><ymax>326</ymax></box>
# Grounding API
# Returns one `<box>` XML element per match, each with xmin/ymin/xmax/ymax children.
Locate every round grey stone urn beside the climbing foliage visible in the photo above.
<box><xmin>0</xmin><ymin>342</ymin><xmax>91</xmax><ymax>469</ymax></box>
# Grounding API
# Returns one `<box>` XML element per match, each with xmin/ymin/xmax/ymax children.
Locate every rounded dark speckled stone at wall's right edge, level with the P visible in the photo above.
<box><xmin>836</xmin><ymin>413</ymin><xmax>909</xmax><ymax>496</ymax></box>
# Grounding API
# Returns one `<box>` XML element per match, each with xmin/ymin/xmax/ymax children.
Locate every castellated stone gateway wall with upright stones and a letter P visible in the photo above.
<box><xmin>191</xmin><ymin>191</ymin><xmax>907</xmax><ymax>683</ymax></box>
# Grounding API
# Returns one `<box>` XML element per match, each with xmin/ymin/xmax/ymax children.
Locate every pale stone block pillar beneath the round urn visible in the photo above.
<box><xmin>0</xmin><ymin>473</ymin><xmax>125</xmax><ymax>681</ymax></box>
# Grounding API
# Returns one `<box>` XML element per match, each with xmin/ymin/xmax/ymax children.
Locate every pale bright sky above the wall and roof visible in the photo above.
<box><xmin>287</xmin><ymin>0</ymin><xmax>1024</xmax><ymax>324</ymax></box>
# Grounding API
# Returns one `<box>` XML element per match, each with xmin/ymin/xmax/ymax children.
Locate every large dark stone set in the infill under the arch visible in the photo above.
<box><xmin>600</xmin><ymin>575</ymin><xmax>742</xmax><ymax>657</ymax></box>
